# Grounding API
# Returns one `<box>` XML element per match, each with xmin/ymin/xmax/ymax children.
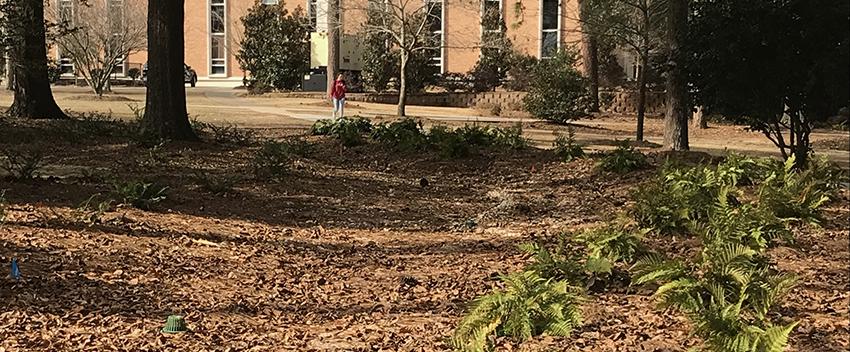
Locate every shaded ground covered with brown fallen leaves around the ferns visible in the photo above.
<box><xmin>0</xmin><ymin>121</ymin><xmax>850</xmax><ymax>351</ymax></box>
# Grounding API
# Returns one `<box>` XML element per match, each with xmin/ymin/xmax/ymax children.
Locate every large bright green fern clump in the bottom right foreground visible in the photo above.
<box><xmin>632</xmin><ymin>242</ymin><xmax>796</xmax><ymax>352</ymax></box>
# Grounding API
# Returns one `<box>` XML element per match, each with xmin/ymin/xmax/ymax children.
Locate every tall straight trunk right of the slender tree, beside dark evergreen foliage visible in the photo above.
<box><xmin>664</xmin><ymin>0</ymin><xmax>691</xmax><ymax>150</ymax></box>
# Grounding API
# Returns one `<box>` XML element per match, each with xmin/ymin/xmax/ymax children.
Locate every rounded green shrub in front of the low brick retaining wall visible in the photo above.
<box><xmin>523</xmin><ymin>50</ymin><xmax>591</xmax><ymax>123</ymax></box>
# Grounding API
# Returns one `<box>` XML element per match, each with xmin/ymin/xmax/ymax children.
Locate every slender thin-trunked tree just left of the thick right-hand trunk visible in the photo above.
<box><xmin>579</xmin><ymin>0</ymin><xmax>667</xmax><ymax>141</ymax></box>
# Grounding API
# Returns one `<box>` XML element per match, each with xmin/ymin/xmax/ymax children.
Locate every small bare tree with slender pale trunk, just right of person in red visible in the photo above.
<box><xmin>361</xmin><ymin>0</ymin><xmax>443</xmax><ymax>116</ymax></box>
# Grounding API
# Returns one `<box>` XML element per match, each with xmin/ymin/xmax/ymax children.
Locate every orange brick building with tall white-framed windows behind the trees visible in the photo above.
<box><xmin>49</xmin><ymin>0</ymin><xmax>581</xmax><ymax>81</ymax></box>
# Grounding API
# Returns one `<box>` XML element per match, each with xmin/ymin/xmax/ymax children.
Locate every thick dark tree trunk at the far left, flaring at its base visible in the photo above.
<box><xmin>6</xmin><ymin>0</ymin><xmax>68</xmax><ymax>119</ymax></box>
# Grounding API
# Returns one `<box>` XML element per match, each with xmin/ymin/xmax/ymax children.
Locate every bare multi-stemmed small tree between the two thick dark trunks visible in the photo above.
<box><xmin>51</xmin><ymin>0</ymin><xmax>147</xmax><ymax>96</ymax></box>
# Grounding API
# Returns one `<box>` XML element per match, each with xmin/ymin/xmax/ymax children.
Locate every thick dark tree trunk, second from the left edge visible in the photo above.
<box><xmin>142</xmin><ymin>0</ymin><xmax>198</xmax><ymax>140</ymax></box>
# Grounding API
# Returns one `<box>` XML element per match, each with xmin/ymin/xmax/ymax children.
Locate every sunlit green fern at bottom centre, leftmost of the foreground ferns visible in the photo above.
<box><xmin>451</xmin><ymin>271</ymin><xmax>581</xmax><ymax>352</ymax></box>
